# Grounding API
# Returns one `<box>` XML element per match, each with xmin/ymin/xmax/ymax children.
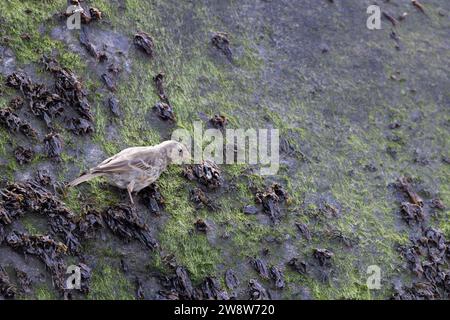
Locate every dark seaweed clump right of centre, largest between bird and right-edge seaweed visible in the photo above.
<box><xmin>255</xmin><ymin>183</ymin><xmax>288</xmax><ymax>223</ymax></box>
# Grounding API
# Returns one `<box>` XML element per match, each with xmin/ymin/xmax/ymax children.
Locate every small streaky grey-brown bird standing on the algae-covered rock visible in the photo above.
<box><xmin>67</xmin><ymin>140</ymin><xmax>191</xmax><ymax>205</ymax></box>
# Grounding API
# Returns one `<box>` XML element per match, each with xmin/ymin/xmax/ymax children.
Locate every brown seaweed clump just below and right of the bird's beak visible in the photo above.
<box><xmin>183</xmin><ymin>160</ymin><xmax>222</xmax><ymax>189</ymax></box>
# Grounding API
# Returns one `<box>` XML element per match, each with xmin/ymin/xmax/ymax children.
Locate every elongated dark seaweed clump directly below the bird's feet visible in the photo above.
<box><xmin>103</xmin><ymin>204</ymin><xmax>158</xmax><ymax>250</ymax></box>
